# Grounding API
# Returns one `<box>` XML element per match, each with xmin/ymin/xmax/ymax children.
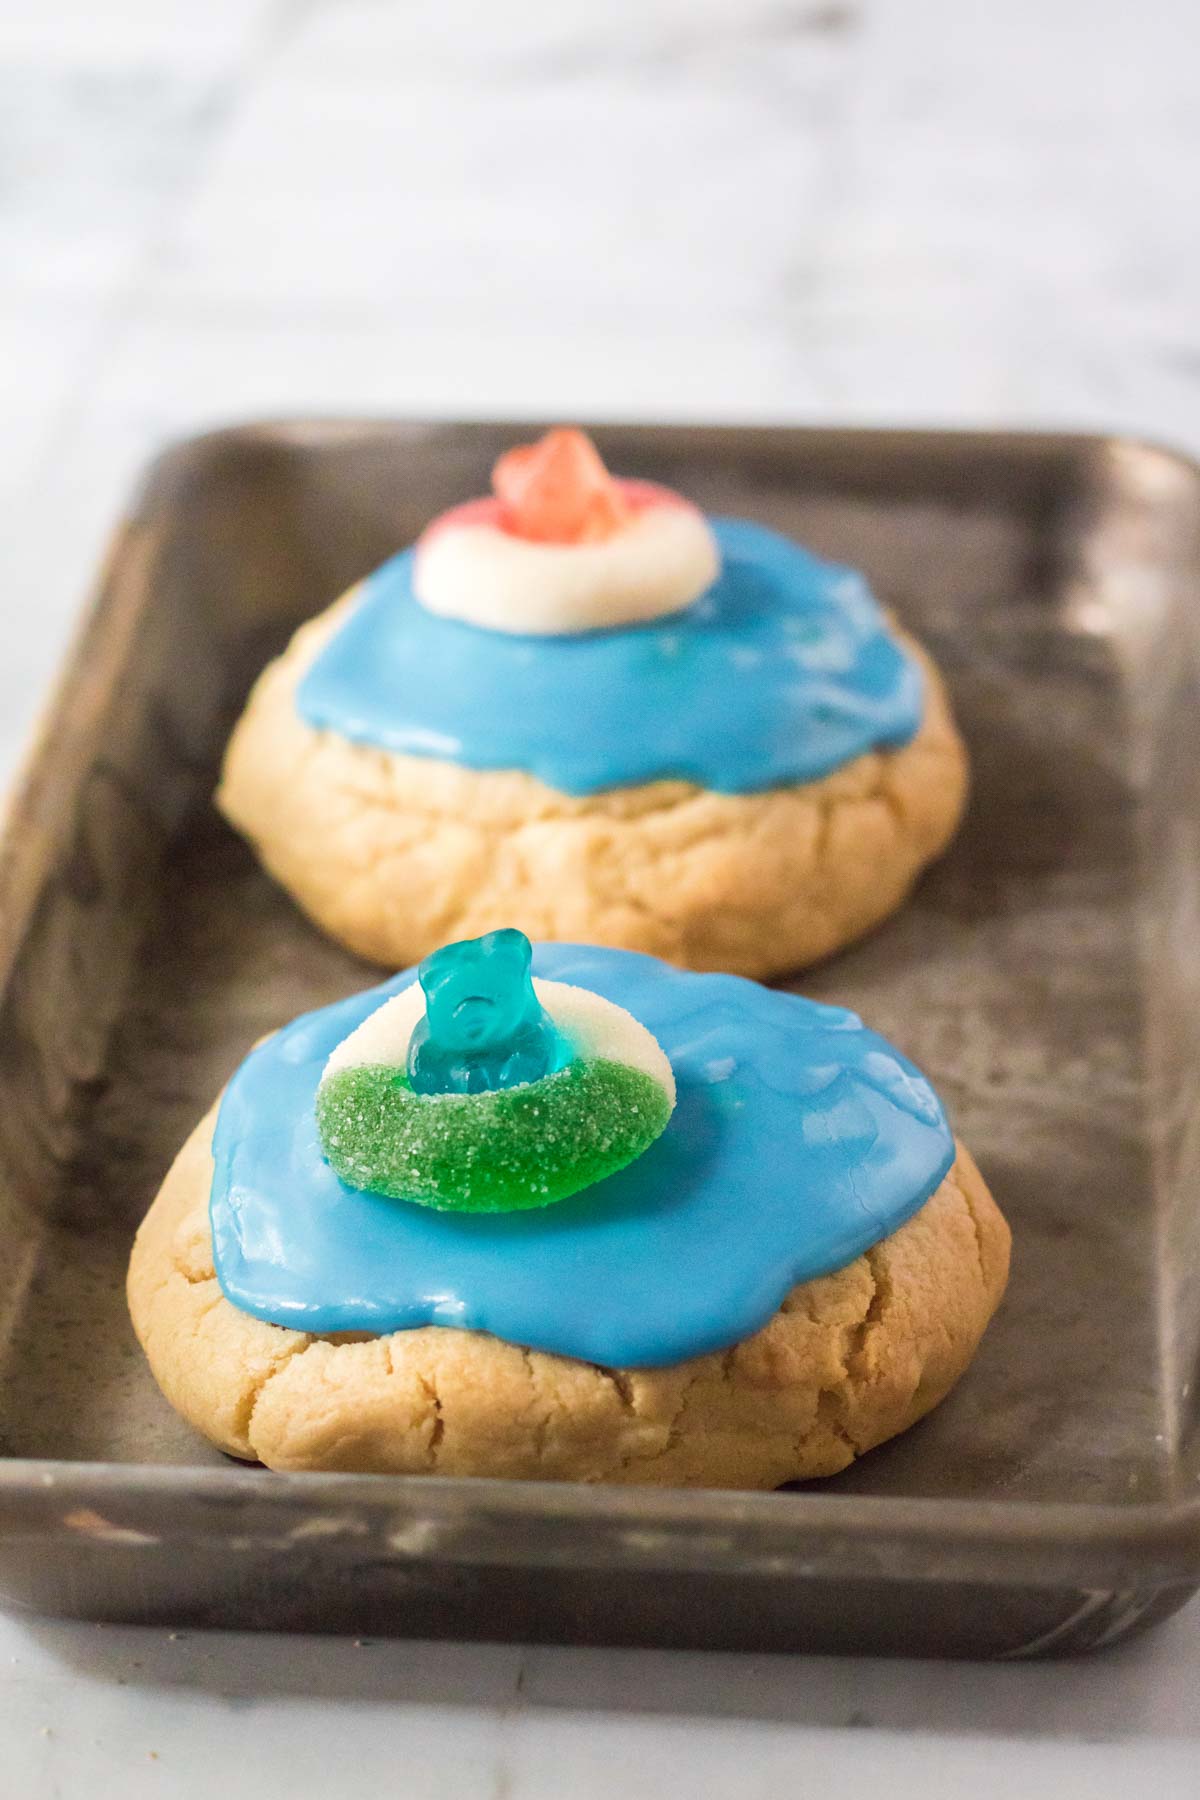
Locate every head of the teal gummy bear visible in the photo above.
<box><xmin>417</xmin><ymin>929</ymin><xmax>542</xmax><ymax>1053</ymax></box>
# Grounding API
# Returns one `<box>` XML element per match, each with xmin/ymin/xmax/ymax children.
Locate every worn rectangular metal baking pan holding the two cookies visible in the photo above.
<box><xmin>0</xmin><ymin>423</ymin><xmax>1200</xmax><ymax>1656</ymax></box>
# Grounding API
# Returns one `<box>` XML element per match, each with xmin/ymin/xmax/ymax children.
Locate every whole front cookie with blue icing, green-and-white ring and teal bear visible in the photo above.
<box><xmin>130</xmin><ymin>931</ymin><xmax>1007</xmax><ymax>1487</ymax></box>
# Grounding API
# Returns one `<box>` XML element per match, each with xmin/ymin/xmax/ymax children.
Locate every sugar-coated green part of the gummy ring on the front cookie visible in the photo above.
<box><xmin>317</xmin><ymin>1060</ymin><xmax>671</xmax><ymax>1213</ymax></box>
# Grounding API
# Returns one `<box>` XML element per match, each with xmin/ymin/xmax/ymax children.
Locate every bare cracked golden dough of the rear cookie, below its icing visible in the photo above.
<box><xmin>216</xmin><ymin>592</ymin><xmax>966</xmax><ymax>977</ymax></box>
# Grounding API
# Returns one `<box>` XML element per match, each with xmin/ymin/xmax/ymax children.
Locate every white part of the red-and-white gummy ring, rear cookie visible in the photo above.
<box><xmin>412</xmin><ymin>502</ymin><xmax>721</xmax><ymax>637</ymax></box>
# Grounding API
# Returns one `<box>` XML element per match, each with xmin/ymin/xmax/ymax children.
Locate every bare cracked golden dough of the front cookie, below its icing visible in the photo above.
<box><xmin>128</xmin><ymin>1107</ymin><xmax>1009</xmax><ymax>1489</ymax></box>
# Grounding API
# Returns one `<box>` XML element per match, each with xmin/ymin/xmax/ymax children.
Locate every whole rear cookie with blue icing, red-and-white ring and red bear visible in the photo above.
<box><xmin>216</xmin><ymin>434</ymin><xmax>966</xmax><ymax>977</ymax></box>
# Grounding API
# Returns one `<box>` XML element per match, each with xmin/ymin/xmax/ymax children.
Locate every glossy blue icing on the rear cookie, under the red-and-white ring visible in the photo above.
<box><xmin>297</xmin><ymin>518</ymin><xmax>923</xmax><ymax>794</ymax></box>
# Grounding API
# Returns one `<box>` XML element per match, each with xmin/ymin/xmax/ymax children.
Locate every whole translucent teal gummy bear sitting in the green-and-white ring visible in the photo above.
<box><xmin>408</xmin><ymin>929</ymin><xmax>569</xmax><ymax>1094</ymax></box>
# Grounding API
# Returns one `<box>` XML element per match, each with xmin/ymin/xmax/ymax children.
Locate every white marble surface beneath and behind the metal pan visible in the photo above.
<box><xmin>0</xmin><ymin>0</ymin><xmax>1200</xmax><ymax>1800</ymax></box>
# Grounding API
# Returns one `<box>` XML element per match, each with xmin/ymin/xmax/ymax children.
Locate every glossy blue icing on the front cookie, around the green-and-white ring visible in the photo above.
<box><xmin>210</xmin><ymin>945</ymin><xmax>954</xmax><ymax>1368</ymax></box>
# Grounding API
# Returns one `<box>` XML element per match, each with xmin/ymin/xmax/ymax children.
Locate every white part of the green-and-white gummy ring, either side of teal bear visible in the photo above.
<box><xmin>320</xmin><ymin>981</ymin><xmax>675</xmax><ymax>1105</ymax></box>
